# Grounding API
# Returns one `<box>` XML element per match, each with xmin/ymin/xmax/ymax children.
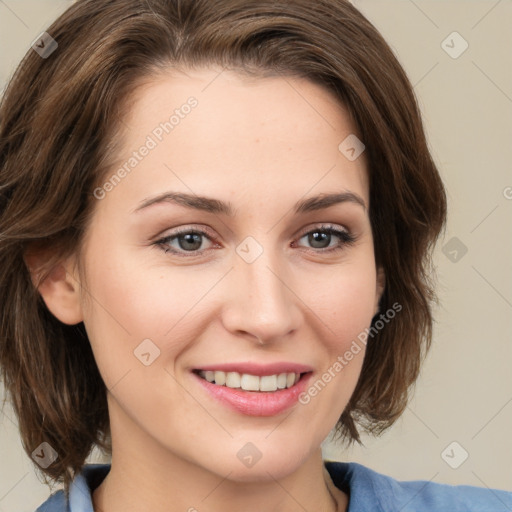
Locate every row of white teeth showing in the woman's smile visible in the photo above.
<box><xmin>199</xmin><ymin>370</ymin><xmax>300</xmax><ymax>391</ymax></box>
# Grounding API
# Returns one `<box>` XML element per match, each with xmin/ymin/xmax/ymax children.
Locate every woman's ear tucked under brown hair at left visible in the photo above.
<box><xmin>24</xmin><ymin>251</ymin><xmax>83</xmax><ymax>325</ymax></box>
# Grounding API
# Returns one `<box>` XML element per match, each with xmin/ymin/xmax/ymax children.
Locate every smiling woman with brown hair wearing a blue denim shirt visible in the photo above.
<box><xmin>0</xmin><ymin>0</ymin><xmax>512</xmax><ymax>512</ymax></box>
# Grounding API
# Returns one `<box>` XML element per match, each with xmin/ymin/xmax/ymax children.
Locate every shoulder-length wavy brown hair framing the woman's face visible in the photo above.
<box><xmin>0</xmin><ymin>0</ymin><xmax>446</xmax><ymax>491</ymax></box>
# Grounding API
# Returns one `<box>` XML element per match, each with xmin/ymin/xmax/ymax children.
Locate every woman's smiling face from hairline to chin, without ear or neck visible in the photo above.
<box><xmin>75</xmin><ymin>69</ymin><xmax>382</xmax><ymax>481</ymax></box>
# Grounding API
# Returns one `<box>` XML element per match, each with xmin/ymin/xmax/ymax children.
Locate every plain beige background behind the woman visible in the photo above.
<box><xmin>0</xmin><ymin>0</ymin><xmax>512</xmax><ymax>512</ymax></box>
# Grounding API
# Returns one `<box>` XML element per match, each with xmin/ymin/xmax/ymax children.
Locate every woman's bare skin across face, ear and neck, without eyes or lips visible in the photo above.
<box><xmin>31</xmin><ymin>68</ymin><xmax>384</xmax><ymax>512</ymax></box>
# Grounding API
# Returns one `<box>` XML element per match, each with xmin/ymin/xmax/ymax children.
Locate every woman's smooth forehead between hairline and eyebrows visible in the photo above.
<box><xmin>97</xmin><ymin>68</ymin><xmax>369</xmax><ymax>216</ymax></box>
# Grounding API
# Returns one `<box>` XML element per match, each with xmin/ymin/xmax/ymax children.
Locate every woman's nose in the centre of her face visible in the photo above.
<box><xmin>222</xmin><ymin>243</ymin><xmax>303</xmax><ymax>345</ymax></box>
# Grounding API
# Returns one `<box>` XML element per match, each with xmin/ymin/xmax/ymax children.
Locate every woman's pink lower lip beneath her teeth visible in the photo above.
<box><xmin>192</xmin><ymin>373</ymin><xmax>312</xmax><ymax>416</ymax></box>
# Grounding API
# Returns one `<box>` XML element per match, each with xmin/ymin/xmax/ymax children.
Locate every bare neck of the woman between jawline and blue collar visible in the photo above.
<box><xmin>92</xmin><ymin>406</ymin><xmax>348</xmax><ymax>512</ymax></box>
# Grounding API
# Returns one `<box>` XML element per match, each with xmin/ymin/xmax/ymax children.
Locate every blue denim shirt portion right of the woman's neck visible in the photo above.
<box><xmin>325</xmin><ymin>461</ymin><xmax>512</xmax><ymax>512</ymax></box>
